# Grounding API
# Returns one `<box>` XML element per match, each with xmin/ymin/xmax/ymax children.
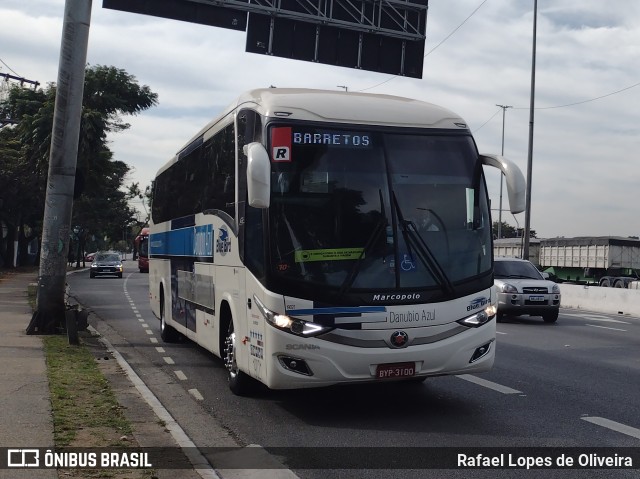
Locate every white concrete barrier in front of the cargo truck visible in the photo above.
<box><xmin>559</xmin><ymin>283</ymin><xmax>640</xmax><ymax>317</ymax></box>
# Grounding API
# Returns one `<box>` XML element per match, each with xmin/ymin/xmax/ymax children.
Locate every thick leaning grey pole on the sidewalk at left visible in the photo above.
<box><xmin>27</xmin><ymin>0</ymin><xmax>92</xmax><ymax>334</ymax></box>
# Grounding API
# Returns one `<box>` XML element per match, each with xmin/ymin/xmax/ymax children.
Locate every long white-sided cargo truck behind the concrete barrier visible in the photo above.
<box><xmin>539</xmin><ymin>236</ymin><xmax>640</xmax><ymax>288</ymax></box>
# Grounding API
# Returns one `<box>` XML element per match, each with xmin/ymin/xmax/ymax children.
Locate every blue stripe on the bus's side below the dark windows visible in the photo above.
<box><xmin>149</xmin><ymin>225</ymin><xmax>213</xmax><ymax>258</ymax></box>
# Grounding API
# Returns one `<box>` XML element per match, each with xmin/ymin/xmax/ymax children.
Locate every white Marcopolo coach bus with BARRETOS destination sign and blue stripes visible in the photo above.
<box><xmin>149</xmin><ymin>88</ymin><xmax>525</xmax><ymax>394</ymax></box>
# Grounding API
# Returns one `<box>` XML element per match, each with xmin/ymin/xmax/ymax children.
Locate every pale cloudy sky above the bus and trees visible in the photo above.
<box><xmin>0</xmin><ymin>0</ymin><xmax>640</xmax><ymax>238</ymax></box>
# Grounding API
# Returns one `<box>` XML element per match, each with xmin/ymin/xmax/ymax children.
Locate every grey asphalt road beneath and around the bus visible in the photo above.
<box><xmin>68</xmin><ymin>261</ymin><xmax>640</xmax><ymax>479</ymax></box>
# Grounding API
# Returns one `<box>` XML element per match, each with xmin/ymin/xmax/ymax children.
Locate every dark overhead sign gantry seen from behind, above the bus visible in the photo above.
<box><xmin>102</xmin><ymin>0</ymin><xmax>428</xmax><ymax>78</ymax></box>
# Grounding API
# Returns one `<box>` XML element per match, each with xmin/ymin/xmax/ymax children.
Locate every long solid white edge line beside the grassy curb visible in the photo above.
<box><xmin>89</xmin><ymin>326</ymin><xmax>220</xmax><ymax>479</ymax></box>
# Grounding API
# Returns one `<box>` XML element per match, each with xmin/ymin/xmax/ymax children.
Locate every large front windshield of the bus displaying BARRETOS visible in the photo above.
<box><xmin>268</xmin><ymin>125</ymin><xmax>492</xmax><ymax>297</ymax></box>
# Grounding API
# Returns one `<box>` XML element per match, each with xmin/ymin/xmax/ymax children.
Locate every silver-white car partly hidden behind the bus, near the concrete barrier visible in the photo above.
<box><xmin>494</xmin><ymin>257</ymin><xmax>560</xmax><ymax>323</ymax></box>
